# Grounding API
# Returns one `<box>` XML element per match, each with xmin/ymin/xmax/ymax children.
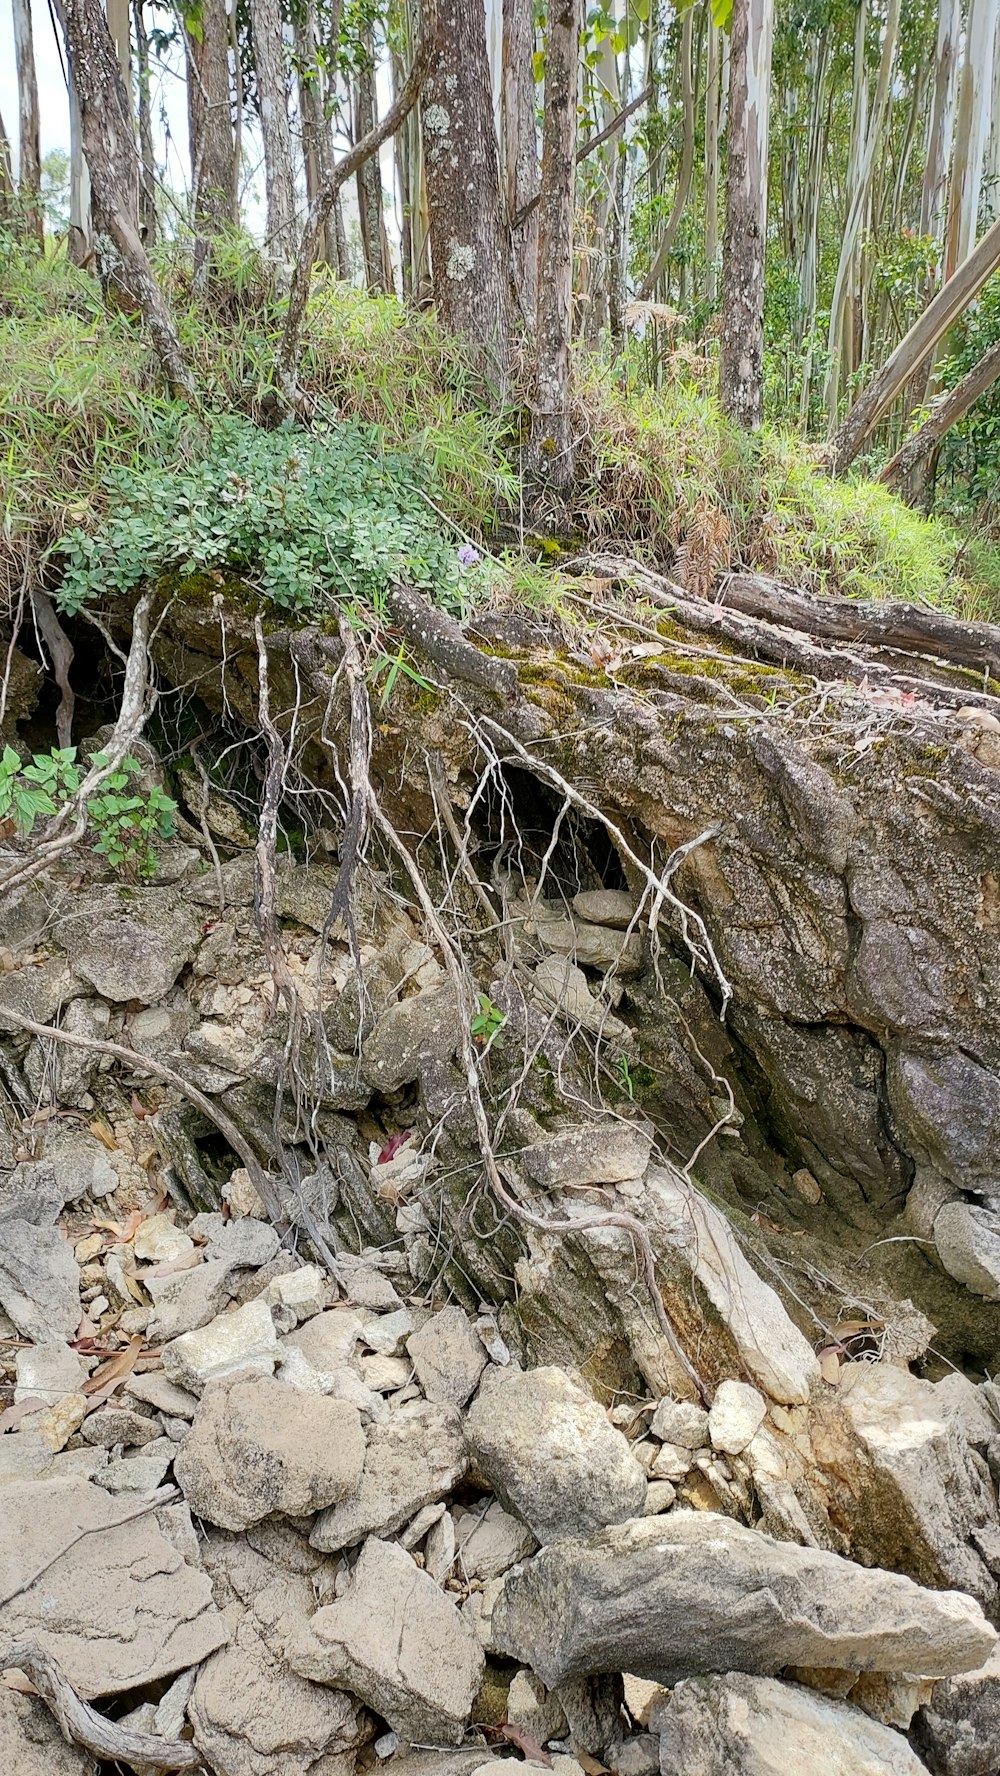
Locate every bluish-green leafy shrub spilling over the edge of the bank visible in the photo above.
<box><xmin>59</xmin><ymin>414</ymin><xmax>458</xmax><ymax>611</ymax></box>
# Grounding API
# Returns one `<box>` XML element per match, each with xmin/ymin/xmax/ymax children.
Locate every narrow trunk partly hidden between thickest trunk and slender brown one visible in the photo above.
<box><xmin>501</xmin><ymin>0</ymin><xmax>538</xmax><ymax>329</ymax></box>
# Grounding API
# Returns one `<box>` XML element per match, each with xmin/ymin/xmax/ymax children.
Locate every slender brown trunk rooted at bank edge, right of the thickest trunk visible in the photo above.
<box><xmin>529</xmin><ymin>0</ymin><xmax>583</xmax><ymax>492</ymax></box>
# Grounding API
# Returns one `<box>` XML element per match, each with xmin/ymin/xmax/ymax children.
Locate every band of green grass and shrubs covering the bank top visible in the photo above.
<box><xmin>0</xmin><ymin>236</ymin><xmax>1000</xmax><ymax>618</ymax></box>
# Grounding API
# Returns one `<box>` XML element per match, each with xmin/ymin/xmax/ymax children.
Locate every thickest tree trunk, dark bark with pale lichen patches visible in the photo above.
<box><xmin>421</xmin><ymin>0</ymin><xmax>512</xmax><ymax>377</ymax></box>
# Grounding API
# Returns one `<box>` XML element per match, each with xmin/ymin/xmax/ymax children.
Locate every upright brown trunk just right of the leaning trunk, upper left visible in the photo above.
<box><xmin>187</xmin><ymin>0</ymin><xmax>236</xmax><ymax>234</ymax></box>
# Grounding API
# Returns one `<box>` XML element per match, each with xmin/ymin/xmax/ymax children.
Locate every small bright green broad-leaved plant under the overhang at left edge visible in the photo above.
<box><xmin>0</xmin><ymin>746</ymin><xmax>178</xmax><ymax>881</ymax></box>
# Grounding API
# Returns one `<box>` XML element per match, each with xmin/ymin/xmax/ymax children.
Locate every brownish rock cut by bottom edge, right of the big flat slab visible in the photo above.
<box><xmin>188</xmin><ymin>1618</ymin><xmax>361</xmax><ymax>1776</ymax></box>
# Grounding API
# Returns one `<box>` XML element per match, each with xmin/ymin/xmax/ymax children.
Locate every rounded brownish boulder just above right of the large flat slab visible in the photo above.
<box><xmin>174</xmin><ymin>1373</ymin><xmax>364</xmax><ymax>1529</ymax></box>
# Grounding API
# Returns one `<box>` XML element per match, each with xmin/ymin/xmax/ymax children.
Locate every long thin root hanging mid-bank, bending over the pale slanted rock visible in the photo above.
<box><xmin>339</xmin><ymin>622</ymin><xmax>712</xmax><ymax>1407</ymax></box>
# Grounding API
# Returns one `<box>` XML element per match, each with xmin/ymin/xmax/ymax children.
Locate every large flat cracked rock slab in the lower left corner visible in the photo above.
<box><xmin>0</xmin><ymin>1458</ymin><xmax>227</xmax><ymax>1698</ymax></box>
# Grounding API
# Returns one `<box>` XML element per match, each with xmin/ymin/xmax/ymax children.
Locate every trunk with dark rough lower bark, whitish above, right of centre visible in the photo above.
<box><xmin>719</xmin><ymin>0</ymin><xmax>774</xmax><ymax>432</ymax></box>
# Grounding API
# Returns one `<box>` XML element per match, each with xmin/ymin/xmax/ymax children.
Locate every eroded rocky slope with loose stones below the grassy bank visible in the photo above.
<box><xmin>0</xmin><ymin>575</ymin><xmax>1000</xmax><ymax>1776</ymax></box>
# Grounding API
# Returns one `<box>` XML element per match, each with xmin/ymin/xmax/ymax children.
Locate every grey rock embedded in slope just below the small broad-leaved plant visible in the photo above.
<box><xmin>59</xmin><ymin>888</ymin><xmax>201</xmax><ymax>1005</ymax></box>
